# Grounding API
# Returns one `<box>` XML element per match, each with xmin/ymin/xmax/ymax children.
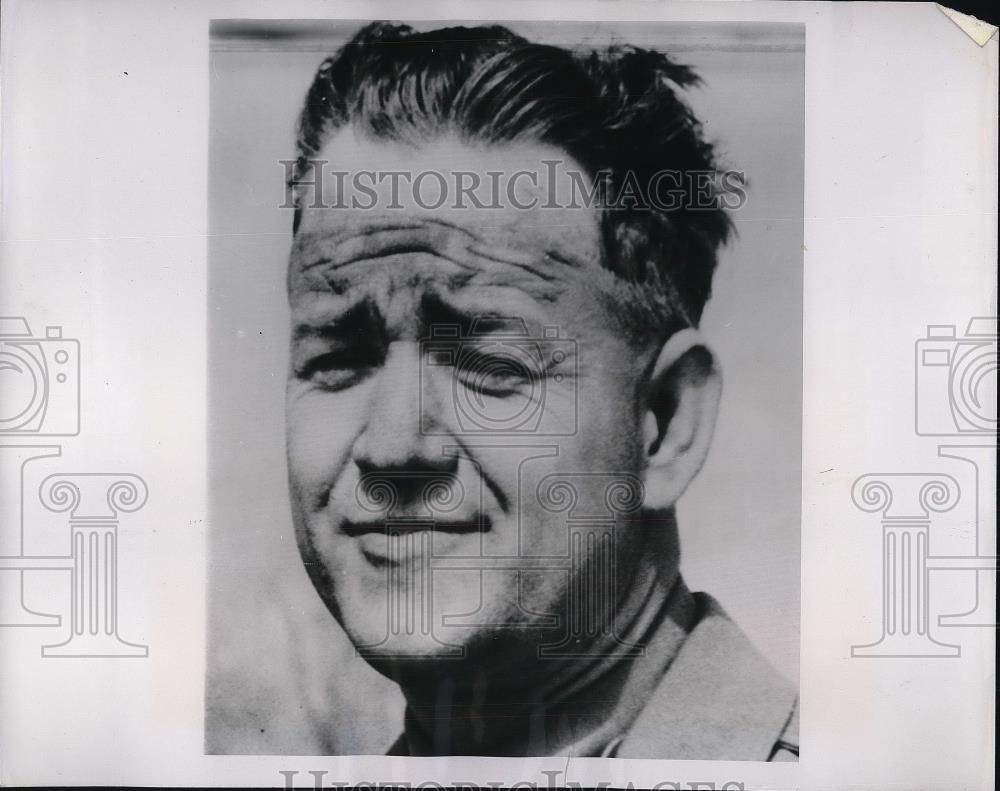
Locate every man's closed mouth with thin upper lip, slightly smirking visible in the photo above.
<box><xmin>340</xmin><ymin>514</ymin><xmax>493</xmax><ymax>568</ymax></box>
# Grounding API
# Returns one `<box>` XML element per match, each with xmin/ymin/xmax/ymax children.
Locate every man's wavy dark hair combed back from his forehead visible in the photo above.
<box><xmin>290</xmin><ymin>22</ymin><xmax>732</xmax><ymax>327</ymax></box>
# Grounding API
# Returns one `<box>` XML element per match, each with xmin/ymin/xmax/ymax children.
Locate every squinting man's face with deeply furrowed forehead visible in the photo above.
<box><xmin>287</xmin><ymin>130</ymin><xmax>648</xmax><ymax>674</ymax></box>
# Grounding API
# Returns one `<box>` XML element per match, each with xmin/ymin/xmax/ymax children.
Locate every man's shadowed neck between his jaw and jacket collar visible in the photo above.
<box><xmin>392</xmin><ymin>524</ymin><xmax>694</xmax><ymax>756</ymax></box>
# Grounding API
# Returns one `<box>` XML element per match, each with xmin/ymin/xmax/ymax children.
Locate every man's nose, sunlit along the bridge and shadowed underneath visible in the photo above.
<box><xmin>353</xmin><ymin>342</ymin><xmax>458</xmax><ymax>475</ymax></box>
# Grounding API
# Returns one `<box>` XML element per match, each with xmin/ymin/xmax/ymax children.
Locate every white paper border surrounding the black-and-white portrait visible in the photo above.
<box><xmin>0</xmin><ymin>1</ymin><xmax>997</xmax><ymax>789</ymax></box>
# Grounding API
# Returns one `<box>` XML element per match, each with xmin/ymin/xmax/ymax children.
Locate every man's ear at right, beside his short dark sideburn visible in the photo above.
<box><xmin>643</xmin><ymin>328</ymin><xmax>722</xmax><ymax>509</ymax></box>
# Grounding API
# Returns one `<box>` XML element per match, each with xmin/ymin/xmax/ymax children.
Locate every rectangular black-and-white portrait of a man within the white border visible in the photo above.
<box><xmin>206</xmin><ymin>20</ymin><xmax>805</xmax><ymax>761</ymax></box>
